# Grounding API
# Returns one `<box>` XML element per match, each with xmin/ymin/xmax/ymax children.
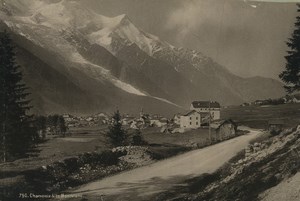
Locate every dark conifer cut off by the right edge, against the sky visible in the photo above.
<box><xmin>279</xmin><ymin>4</ymin><xmax>300</xmax><ymax>93</ymax></box>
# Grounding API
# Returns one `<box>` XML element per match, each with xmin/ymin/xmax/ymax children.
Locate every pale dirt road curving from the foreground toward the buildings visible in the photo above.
<box><xmin>68</xmin><ymin>130</ymin><xmax>260</xmax><ymax>201</ymax></box>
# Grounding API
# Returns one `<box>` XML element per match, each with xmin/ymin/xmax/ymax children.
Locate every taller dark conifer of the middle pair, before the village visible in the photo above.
<box><xmin>106</xmin><ymin>110</ymin><xmax>128</xmax><ymax>147</ymax></box>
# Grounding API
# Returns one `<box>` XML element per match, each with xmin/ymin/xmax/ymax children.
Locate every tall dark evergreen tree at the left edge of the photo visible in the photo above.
<box><xmin>0</xmin><ymin>31</ymin><xmax>37</xmax><ymax>161</ymax></box>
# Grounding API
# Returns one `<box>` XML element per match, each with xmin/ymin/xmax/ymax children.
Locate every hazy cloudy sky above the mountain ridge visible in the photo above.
<box><xmin>83</xmin><ymin>0</ymin><xmax>297</xmax><ymax>79</ymax></box>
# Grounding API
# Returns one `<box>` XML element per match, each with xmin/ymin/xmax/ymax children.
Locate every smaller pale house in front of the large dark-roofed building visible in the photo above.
<box><xmin>180</xmin><ymin>110</ymin><xmax>201</xmax><ymax>128</ymax></box>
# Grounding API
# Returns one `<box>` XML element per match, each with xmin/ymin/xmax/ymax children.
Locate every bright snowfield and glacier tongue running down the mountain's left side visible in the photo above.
<box><xmin>0</xmin><ymin>0</ymin><xmax>152</xmax><ymax>96</ymax></box>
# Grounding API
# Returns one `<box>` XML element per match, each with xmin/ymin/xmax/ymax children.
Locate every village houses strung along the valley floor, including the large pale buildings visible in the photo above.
<box><xmin>64</xmin><ymin>101</ymin><xmax>237</xmax><ymax>140</ymax></box>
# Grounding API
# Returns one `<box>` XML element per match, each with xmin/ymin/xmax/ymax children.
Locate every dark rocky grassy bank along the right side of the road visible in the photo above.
<box><xmin>157</xmin><ymin>128</ymin><xmax>300</xmax><ymax>201</ymax></box>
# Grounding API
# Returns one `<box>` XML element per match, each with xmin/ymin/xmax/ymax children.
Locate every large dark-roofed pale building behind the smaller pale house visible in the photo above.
<box><xmin>190</xmin><ymin>101</ymin><xmax>221</xmax><ymax>120</ymax></box>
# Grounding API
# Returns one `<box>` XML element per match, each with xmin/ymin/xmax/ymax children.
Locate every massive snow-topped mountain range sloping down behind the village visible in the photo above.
<box><xmin>0</xmin><ymin>0</ymin><xmax>284</xmax><ymax>114</ymax></box>
